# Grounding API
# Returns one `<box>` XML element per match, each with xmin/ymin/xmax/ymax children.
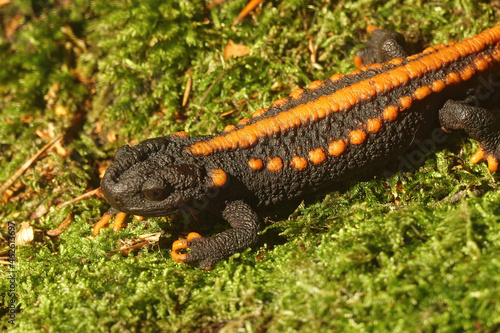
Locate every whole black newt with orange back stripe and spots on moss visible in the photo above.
<box><xmin>95</xmin><ymin>25</ymin><xmax>500</xmax><ymax>269</ymax></box>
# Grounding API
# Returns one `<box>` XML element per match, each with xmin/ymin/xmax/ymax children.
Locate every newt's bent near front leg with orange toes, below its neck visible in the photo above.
<box><xmin>171</xmin><ymin>200</ymin><xmax>259</xmax><ymax>270</ymax></box>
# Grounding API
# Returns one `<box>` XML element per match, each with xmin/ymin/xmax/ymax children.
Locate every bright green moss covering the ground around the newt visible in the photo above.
<box><xmin>0</xmin><ymin>0</ymin><xmax>500</xmax><ymax>332</ymax></box>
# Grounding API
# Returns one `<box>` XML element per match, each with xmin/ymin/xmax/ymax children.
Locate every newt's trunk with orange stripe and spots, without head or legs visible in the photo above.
<box><xmin>192</xmin><ymin>26</ymin><xmax>500</xmax><ymax>205</ymax></box>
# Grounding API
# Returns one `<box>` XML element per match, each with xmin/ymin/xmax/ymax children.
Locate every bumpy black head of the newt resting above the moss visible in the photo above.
<box><xmin>101</xmin><ymin>137</ymin><xmax>214</xmax><ymax>216</ymax></box>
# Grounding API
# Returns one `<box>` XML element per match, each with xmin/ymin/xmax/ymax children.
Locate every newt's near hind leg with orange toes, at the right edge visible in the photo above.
<box><xmin>439</xmin><ymin>100</ymin><xmax>500</xmax><ymax>172</ymax></box>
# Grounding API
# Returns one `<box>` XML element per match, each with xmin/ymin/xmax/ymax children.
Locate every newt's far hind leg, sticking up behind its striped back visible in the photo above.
<box><xmin>354</xmin><ymin>25</ymin><xmax>408</xmax><ymax>68</ymax></box>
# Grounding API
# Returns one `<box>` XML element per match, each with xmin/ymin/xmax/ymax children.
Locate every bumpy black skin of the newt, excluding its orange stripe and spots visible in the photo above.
<box><xmin>101</xmin><ymin>27</ymin><xmax>500</xmax><ymax>268</ymax></box>
